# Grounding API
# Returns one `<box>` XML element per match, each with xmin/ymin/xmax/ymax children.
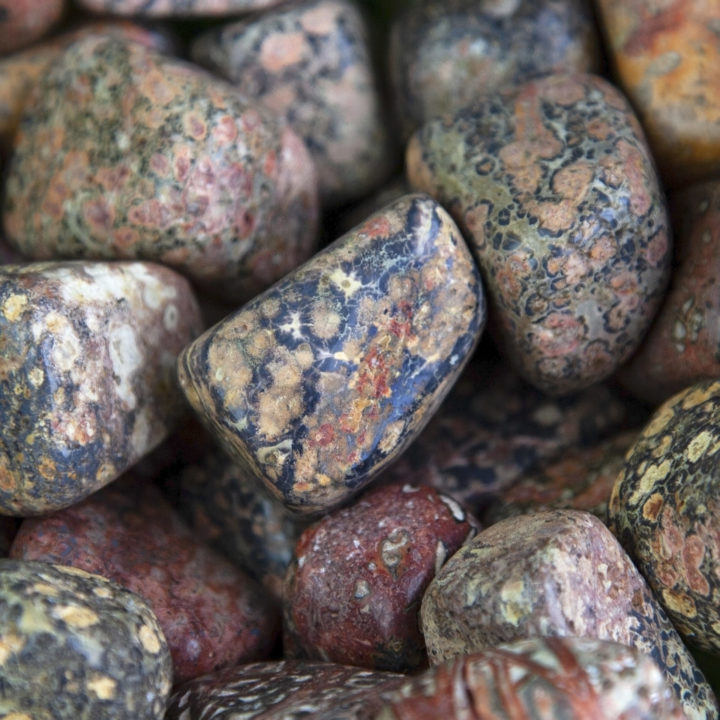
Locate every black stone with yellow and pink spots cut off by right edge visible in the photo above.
<box><xmin>609</xmin><ymin>380</ymin><xmax>720</xmax><ymax>655</ymax></box>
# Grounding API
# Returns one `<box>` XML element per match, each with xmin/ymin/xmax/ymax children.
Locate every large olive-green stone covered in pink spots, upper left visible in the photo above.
<box><xmin>4</xmin><ymin>37</ymin><xmax>317</xmax><ymax>301</ymax></box>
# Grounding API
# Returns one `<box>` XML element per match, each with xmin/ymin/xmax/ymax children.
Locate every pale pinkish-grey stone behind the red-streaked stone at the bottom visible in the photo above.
<box><xmin>420</xmin><ymin>510</ymin><xmax>718</xmax><ymax>718</ymax></box>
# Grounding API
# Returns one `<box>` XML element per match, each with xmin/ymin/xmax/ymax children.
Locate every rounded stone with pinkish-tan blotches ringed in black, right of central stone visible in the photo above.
<box><xmin>407</xmin><ymin>75</ymin><xmax>671</xmax><ymax>394</ymax></box>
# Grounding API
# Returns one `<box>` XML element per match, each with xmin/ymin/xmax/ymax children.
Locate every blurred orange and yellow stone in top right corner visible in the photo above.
<box><xmin>597</xmin><ymin>0</ymin><xmax>720</xmax><ymax>186</ymax></box>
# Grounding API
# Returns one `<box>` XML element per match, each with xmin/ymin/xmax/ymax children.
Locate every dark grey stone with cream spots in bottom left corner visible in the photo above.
<box><xmin>0</xmin><ymin>560</ymin><xmax>172</xmax><ymax>720</ymax></box>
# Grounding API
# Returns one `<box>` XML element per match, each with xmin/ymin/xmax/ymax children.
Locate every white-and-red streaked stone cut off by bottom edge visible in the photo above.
<box><xmin>375</xmin><ymin>637</ymin><xmax>685</xmax><ymax>720</ymax></box>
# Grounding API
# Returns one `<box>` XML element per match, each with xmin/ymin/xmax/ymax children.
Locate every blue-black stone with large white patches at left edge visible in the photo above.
<box><xmin>0</xmin><ymin>262</ymin><xmax>201</xmax><ymax>515</ymax></box>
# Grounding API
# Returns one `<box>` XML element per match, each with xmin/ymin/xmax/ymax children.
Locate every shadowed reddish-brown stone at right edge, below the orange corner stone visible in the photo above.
<box><xmin>618</xmin><ymin>180</ymin><xmax>720</xmax><ymax>404</ymax></box>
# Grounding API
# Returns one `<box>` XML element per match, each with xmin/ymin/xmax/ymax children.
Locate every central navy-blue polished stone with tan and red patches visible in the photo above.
<box><xmin>178</xmin><ymin>195</ymin><xmax>485</xmax><ymax>513</ymax></box>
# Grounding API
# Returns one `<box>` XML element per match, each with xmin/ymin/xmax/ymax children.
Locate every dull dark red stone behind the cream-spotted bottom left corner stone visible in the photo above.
<box><xmin>10</xmin><ymin>478</ymin><xmax>279</xmax><ymax>682</ymax></box>
